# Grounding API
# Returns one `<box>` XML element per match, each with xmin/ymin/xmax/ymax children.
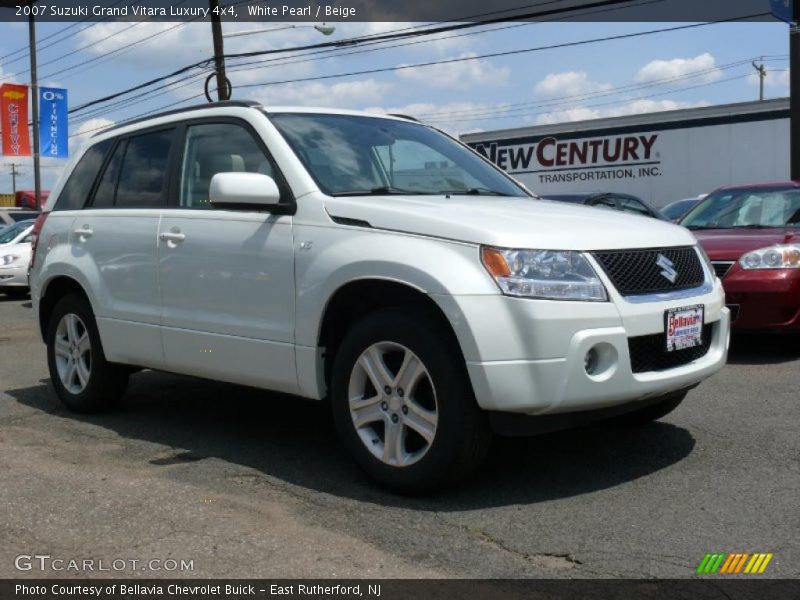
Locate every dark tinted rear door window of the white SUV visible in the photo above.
<box><xmin>115</xmin><ymin>129</ymin><xmax>175</xmax><ymax>208</ymax></box>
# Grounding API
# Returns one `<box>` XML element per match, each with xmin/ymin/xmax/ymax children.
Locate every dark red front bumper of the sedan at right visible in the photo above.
<box><xmin>722</xmin><ymin>264</ymin><xmax>800</xmax><ymax>332</ymax></box>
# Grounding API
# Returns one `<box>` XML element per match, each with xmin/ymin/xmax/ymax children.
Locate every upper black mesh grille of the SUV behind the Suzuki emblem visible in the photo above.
<box><xmin>592</xmin><ymin>246</ymin><xmax>705</xmax><ymax>296</ymax></box>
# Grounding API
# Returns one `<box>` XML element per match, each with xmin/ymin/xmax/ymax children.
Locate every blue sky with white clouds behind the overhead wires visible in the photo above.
<box><xmin>0</xmin><ymin>15</ymin><xmax>789</xmax><ymax>193</ymax></box>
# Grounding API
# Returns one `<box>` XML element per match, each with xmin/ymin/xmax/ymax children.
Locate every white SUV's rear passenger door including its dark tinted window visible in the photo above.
<box><xmin>72</xmin><ymin>126</ymin><xmax>176</xmax><ymax>368</ymax></box>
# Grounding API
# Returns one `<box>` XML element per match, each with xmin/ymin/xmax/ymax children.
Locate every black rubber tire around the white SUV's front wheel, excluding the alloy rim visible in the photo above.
<box><xmin>331</xmin><ymin>309</ymin><xmax>488</xmax><ymax>493</ymax></box>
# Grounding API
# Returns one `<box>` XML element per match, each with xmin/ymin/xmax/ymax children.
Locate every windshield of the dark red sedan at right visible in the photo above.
<box><xmin>681</xmin><ymin>188</ymin><xmax>800</xmax><ymax>229</ymax></box>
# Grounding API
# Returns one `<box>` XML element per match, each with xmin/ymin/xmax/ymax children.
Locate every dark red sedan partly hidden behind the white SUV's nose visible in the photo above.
<box><xmin>681</xmin><ymin>181</ymin><xmax>800</xmax><ymax>332</ymax></box>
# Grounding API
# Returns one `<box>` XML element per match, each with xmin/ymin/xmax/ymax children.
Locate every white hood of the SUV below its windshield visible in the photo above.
<box><xmin>326</xmin><ymin>195</ymin><xmax>696</xmax><ymax>250</ymax></box>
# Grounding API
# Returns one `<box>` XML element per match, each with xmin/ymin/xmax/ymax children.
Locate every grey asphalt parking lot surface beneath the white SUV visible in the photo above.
<box><xmin>0</xmin><ymin>295</ymin><xmax>800</xmax><ymax>578</ymax></box>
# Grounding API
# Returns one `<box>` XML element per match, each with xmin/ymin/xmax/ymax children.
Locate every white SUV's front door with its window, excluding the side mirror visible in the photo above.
<box><xmin>158</xmin><ymin>118</ymin><xmax>297</xmax><ymax>392</ymax></box>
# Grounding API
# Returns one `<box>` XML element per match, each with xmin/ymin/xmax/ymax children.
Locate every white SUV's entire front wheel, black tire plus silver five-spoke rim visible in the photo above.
<box><xmin>331</xmin><ymin>309</ymin><xmax>491</xmax><ymax>494</ymax></box>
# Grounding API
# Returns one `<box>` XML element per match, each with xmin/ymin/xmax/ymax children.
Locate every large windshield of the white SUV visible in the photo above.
<box><xmin>269</xmin><ymin>113</ymin><xmax>528</xmax><ymax>196</ymax></box>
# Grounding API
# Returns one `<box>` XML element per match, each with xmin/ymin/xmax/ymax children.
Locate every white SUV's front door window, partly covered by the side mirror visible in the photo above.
<box><xmin>180</xmin><ymin>123</ymin><xmax>280</xmax><ymax>208</ymax></box>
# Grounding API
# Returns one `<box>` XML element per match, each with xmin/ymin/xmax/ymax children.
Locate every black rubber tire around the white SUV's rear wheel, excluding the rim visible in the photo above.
<box><xmin>47</xmin><ymin>294</ymin><xmax>127</xmax><ymax>413</ymax></box>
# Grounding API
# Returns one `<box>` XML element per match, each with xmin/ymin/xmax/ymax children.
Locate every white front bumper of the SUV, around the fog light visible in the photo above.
<box><xmin>440</xmin><ymin>280</ymin><xmax>730</xmax><ymax>415</ymax></box>
